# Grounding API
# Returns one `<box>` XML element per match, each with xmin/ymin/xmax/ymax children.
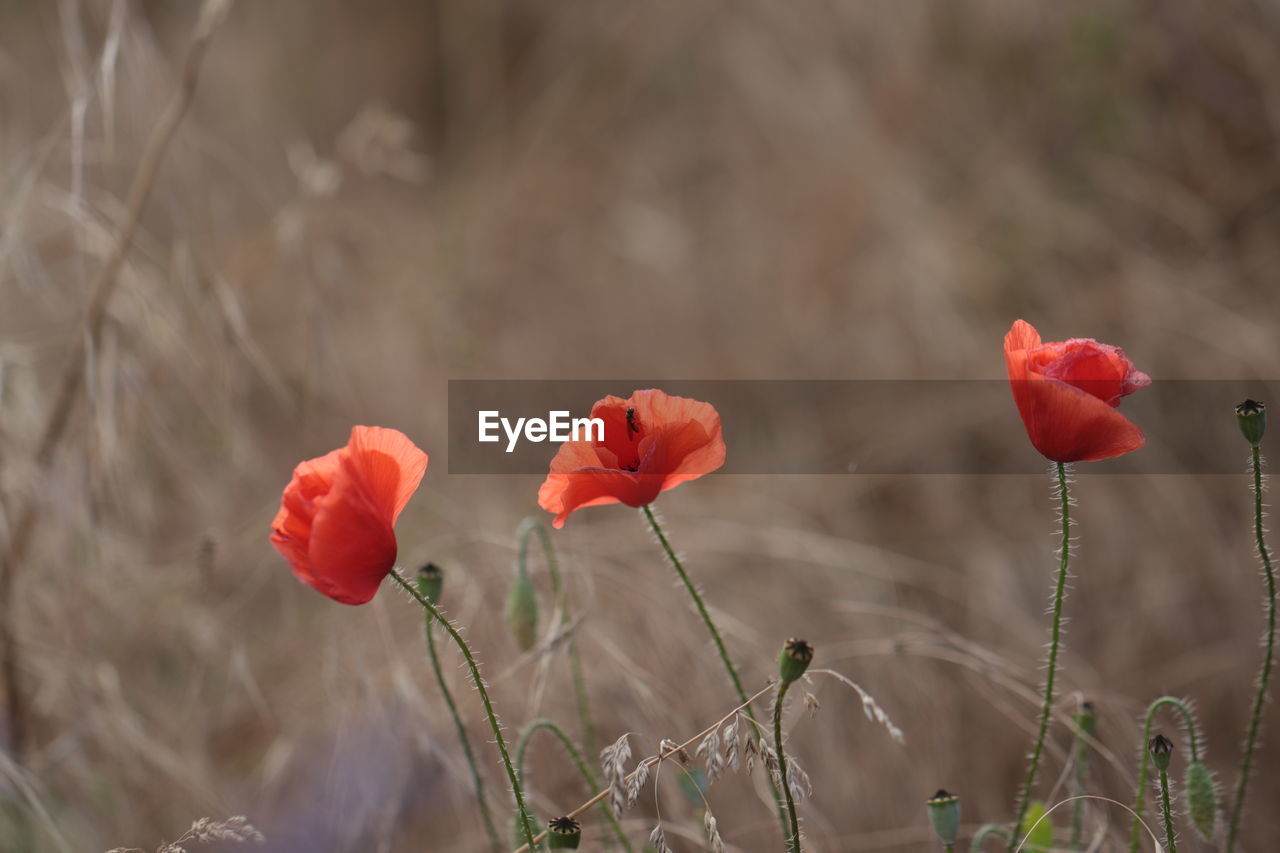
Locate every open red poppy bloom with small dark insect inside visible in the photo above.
<box><xmin>538</xmin><ymin>389</ymin><xmax>724</xmax><ymax>528</ymax></box>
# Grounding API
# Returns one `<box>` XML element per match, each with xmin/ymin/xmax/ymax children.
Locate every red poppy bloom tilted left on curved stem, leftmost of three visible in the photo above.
<box><xmin>271</xmin><ymin>427</ymin><xmax>426</xmax><ymax>596</ymax></box>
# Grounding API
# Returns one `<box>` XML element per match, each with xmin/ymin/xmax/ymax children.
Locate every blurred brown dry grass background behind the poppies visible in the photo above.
<box><xmin>0</xmin><ymin>0</ymin><xmax>1280</xmax><ymax>852</ymax></box>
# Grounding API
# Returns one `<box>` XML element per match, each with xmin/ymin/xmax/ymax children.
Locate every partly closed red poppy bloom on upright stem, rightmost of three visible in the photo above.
<box><xmin>1005</xmin><ymin>320</ymin><xmax>1151</xmax><ymax>462</ymax></box>
